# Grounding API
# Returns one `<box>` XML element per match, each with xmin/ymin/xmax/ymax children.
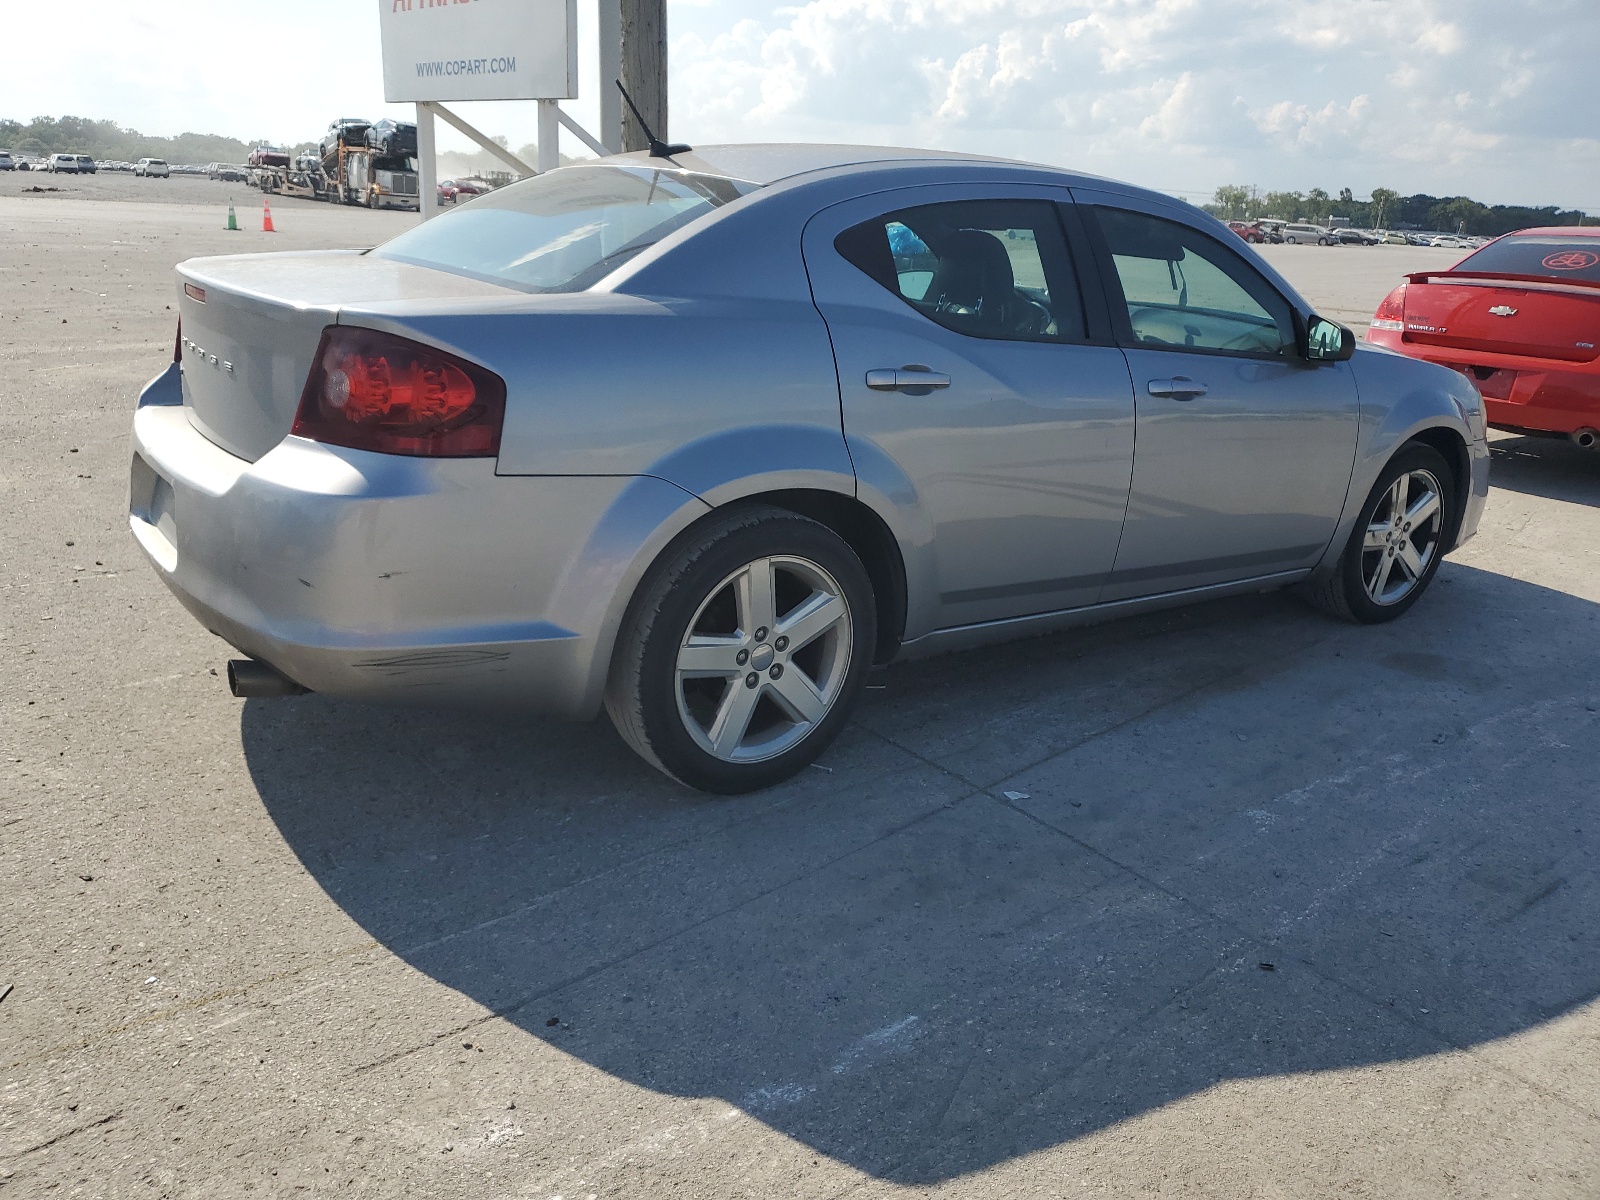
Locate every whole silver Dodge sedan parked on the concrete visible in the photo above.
<box><xmin>131</xmin><ymin>146</ymin><xmax>1488</xmax><ymax>792</ymax></box>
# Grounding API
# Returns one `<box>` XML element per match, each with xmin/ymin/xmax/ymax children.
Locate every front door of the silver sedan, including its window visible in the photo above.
<box><xmin>1074</xmin><ymin>189</ymin><xmax>1358</xmax><ymax>600</ymax></box>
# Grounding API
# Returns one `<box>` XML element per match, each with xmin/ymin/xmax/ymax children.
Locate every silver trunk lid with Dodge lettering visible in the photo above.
<box><xmin>178</xmin><ymin>250</ymin><xmax>520</xmax><ymax>462</ymax></box>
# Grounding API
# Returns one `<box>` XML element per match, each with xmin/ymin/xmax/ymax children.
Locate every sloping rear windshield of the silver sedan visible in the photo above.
<box><xmin>373</xmin><ymin>165</ymin><xmax>755</xmax><ymax>291</ymax></box>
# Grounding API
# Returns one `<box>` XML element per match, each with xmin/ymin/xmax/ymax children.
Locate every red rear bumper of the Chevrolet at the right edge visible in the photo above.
<box><xmin>1366</xmin><ymin>330</ymin><xmax>1600</xmax><ymax>434</ymax></box>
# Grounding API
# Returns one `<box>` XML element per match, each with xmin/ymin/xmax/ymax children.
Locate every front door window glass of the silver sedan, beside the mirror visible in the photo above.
<box><xmin>1094</xmin><ymin>208</ymin><xmax>1294</xmax><ymax>357</ymax></box>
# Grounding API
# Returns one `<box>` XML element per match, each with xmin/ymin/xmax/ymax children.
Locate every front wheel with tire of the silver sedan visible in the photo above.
<box><xmin>1304</xmin><ymin>442</ymin><xmax>1461</xmax><ymax>626</ymax></box>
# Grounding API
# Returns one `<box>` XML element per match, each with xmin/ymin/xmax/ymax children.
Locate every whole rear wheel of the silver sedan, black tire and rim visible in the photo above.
<box><xmin>605</xmin><ymin>506</ymin><xmax>877</xmax><ymax>795</ymax></box>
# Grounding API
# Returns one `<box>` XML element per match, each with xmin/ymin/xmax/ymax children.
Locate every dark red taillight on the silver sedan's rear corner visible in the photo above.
<box><xmin>290</xmin><ymin>325</ymin><xmax>506</xmax><ymax>458</ymax></box>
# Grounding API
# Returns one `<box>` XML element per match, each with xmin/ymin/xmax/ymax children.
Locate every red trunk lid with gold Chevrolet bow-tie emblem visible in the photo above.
<box><xmin>1403</xmin><ymin>272</ymin><xmax>1600</xmax><ymax>363</ymax></box>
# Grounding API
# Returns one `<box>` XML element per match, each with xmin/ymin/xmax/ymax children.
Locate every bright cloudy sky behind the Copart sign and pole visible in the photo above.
<box><xmin>0</xmin><ymin>0</ymin><xmax>1600</xmax><ymax>214</ymax></box>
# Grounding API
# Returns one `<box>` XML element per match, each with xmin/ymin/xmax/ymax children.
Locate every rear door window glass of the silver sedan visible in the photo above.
<box><xmin>834</xmin><ymin>200</ymin><xmax>1086</xmax><ymax>341</ymax></box>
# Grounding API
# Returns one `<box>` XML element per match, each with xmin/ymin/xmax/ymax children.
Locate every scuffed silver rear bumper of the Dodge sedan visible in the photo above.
<box><xmin>128</xmin><ymin>370</ymin><xmax>685</xmax><ymax>718</ymax></box>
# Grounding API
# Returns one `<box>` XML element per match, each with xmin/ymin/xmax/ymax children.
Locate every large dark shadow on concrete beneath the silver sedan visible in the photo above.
<box><xmin>242</xmin><ymin>563</ymin><xmax>1600</xmax><ymax>1182</ymax></box>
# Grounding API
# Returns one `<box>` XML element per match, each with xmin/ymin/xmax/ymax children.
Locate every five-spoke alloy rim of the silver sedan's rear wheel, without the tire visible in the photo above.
<box><xmin>674</xmin><ymin>555</ymin><xmax>854</xmax><ymax>763</ymax></box>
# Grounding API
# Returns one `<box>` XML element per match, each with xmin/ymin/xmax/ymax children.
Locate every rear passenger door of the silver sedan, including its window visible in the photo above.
<box><xmin>805</xmin><ymin>186</ymin><xmax>1134</xmax><ymax>637</ymax></box>
